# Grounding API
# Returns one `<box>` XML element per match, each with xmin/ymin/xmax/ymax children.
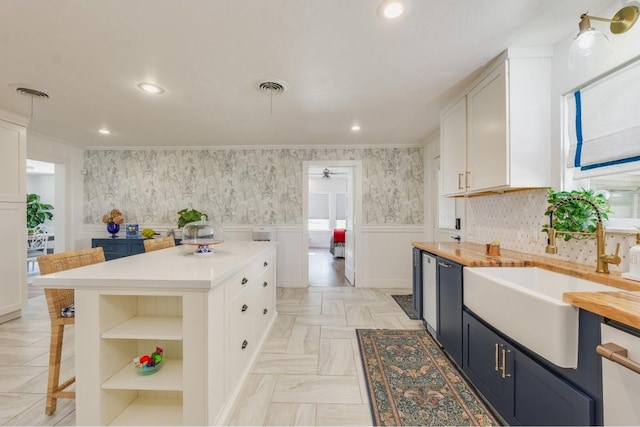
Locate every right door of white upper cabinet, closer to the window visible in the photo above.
<box><xmin>467</xmin><ymin>61</ymin><xmax>510</xmax><ymax>191</ymax></box>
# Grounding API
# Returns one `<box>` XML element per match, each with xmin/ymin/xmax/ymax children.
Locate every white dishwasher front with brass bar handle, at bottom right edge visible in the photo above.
<box><xmin>596</xmin><ymin>321</ymin><xmax>640</xmax><ymax>426</ymax></box>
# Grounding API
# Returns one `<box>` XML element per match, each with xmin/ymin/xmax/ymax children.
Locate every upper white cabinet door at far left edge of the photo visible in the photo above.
<box><xmin>0</xmin><ymin>120</ymin><xmax>27</xmax><ymax>202</ymax></box>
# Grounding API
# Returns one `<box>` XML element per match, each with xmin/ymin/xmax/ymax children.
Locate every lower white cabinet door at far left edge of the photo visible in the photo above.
<box><xmin>0</xmin><ymin>202</ymin><xmax>27</xmax><ymax>322</ymax></box>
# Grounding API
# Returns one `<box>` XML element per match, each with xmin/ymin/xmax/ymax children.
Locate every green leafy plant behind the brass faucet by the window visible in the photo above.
<box><xmin>542</xmin><ymin>188</ymin><xmax>613</xmax><ymax>241</ymax></box>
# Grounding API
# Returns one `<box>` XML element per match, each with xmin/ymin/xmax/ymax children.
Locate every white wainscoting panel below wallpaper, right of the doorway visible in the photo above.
<box><xmin>356</xmin><ymin>225</ymin><xmax>424</xmax><ymax>290</ymax></box>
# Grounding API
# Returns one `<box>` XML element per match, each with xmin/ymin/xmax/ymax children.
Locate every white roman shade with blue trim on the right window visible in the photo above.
<box><xmin>565</xmin><ymin>57</ymin><xmax>640</xmax><ymax>179</ymax></box>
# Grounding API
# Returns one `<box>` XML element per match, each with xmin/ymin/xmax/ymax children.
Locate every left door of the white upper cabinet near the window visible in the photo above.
<box><xmin>440</xmin><ymin>97</ymin><xmax>467</xmax><ymax>196</ymax></box>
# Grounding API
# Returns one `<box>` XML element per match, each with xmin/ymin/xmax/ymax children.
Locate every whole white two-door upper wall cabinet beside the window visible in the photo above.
<box><xmin>440</xmin><ymin>49</ymin><xmax>551</xmax><ymax>196</ymax></box>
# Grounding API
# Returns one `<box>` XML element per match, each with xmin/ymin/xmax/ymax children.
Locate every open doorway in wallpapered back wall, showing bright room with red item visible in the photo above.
<box><xmin>303</xmin><ymin>161</ymin><xmax>361</xmax><ymax>287</ymax></box>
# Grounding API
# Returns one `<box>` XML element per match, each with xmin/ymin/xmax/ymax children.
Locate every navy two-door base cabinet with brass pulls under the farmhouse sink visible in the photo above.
<box><xmin>463</xmin><ymin>311</ymin><xmax>596</xmax><ymax>426</ymax></box>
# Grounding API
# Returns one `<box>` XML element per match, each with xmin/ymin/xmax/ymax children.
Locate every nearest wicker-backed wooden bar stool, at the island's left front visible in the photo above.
<box><xmin>38</xmin><ymin>248</ymin><xmax>105</xmax><ymax>415</ymax></box>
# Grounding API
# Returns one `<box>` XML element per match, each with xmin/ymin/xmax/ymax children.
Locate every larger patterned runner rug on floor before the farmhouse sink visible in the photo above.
<box><xmin>356</xmin><ymin>329</ymin><xmax>500</xmax><ymax>426</ymax></box>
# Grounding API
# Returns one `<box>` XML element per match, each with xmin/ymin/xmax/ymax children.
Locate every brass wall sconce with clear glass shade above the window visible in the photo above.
<box><xmin>569</xmin><ymin>6</ymin><xmax>640</xmax><ymax>70</ymax></box>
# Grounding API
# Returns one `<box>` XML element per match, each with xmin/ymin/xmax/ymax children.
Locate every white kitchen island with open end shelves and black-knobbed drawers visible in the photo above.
<box><xmin>34</xmin><ymin>241</ymin><xmax>276</xmax><ymax>425</ymax></box>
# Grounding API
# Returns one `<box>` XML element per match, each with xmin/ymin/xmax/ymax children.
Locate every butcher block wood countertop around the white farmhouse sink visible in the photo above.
<box><xmin>412</xmin><ymin>242</ymin><xmax>640</xmax><ymax>329</ymax></box>
